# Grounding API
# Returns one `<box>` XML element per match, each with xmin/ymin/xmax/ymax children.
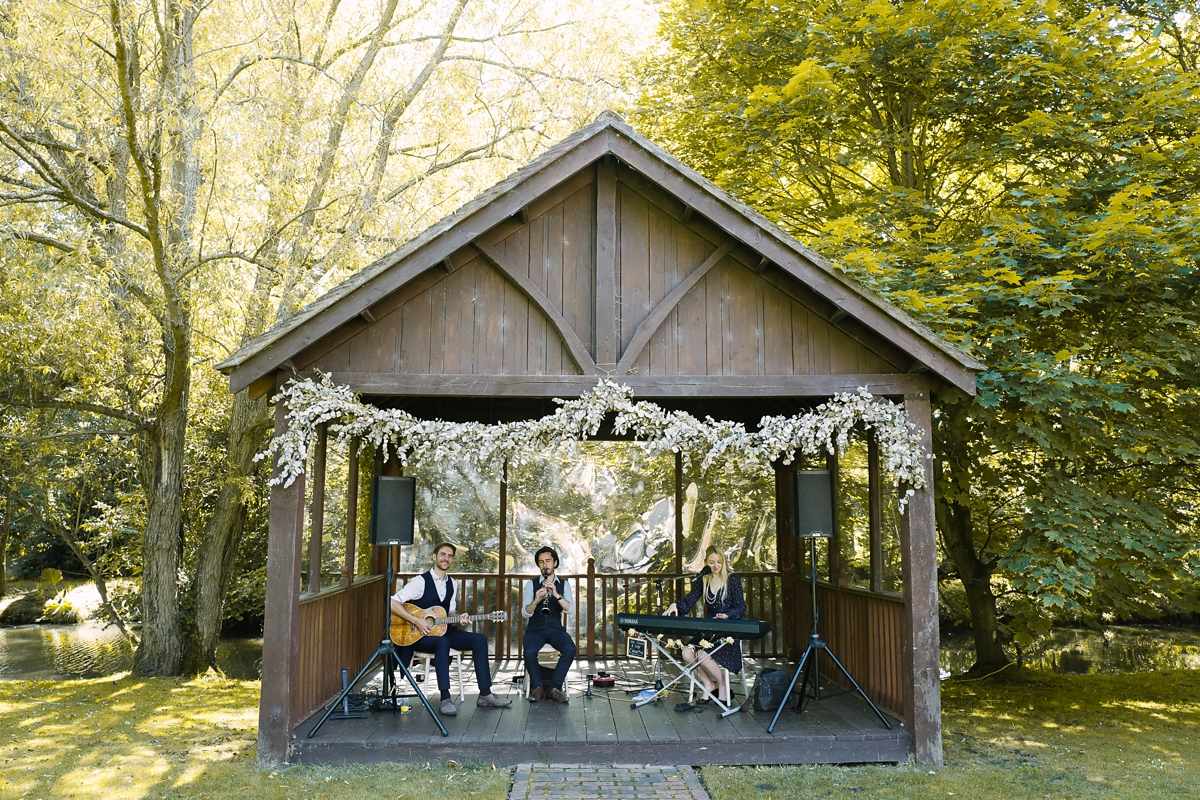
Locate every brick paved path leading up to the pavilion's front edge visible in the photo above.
<box><xmin>509</xmin><ymin>764</ymin><xmax>709</xmax><ymax>800</ymax></box>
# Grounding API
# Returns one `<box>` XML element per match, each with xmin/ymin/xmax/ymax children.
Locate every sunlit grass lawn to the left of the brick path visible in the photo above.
<box><xmin>0</xmin><ymin>673</ymin><xmax>509</xmax><ymax>800</ymax></box>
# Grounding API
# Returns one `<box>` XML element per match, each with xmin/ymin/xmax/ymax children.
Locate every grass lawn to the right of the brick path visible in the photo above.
<box><xmin>702</xmin><ymin>670</ymin><xmax>1200</xmax><ymax>800</ymax></box>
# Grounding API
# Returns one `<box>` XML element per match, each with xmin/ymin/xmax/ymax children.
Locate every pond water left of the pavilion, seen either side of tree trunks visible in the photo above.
<box><xmin>0</xmin><ymin>622</ymin><xmax>263</xmax><ymax>680</ymax></box>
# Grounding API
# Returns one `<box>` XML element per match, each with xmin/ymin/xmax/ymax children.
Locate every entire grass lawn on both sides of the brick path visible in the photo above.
<box><xmin>0</xmin><ymin>672</ymin><xmax>1200</xmax><ymax>800</ymax></box>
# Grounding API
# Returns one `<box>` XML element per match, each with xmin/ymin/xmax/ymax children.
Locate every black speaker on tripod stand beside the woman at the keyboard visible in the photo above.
<box><xmin>767</xmin><ymin>469</ymin><xmax>892</xmax><ymax>733</ymax></box>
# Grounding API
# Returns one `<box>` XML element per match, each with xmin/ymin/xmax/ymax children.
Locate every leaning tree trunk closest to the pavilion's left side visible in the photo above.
<box><xmin>185</xmin><ymin>391</ymin><xmax>271</xmax><ymax>673</ymax></box>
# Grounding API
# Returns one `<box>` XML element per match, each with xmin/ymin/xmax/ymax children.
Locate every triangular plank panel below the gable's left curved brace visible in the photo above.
<box><xmin>312</xmin><ymin>258</ymin><xmax>581</xmax><ymax>375</ymax></box>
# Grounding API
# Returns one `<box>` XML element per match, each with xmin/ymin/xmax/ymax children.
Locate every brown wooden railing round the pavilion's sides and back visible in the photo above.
<box><xmin>294</xmin><ymin>571</ymin><xmax>904</xmax><ymax>720</ymax></box>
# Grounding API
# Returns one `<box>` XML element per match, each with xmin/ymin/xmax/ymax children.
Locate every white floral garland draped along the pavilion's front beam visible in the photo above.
<box><xmin>256</xmin><ymin>374</ymin><xmax>931</xmax><ymax>512</ymax></box>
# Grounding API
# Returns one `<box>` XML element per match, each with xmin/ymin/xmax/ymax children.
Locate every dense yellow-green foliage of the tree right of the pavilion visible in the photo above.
<box><xmin>641</xmin><ymin>0</ymin><xmax>1200</xmax><ymax>632</ymax></box>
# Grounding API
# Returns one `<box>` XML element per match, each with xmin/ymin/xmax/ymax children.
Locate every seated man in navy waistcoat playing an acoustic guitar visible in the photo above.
<box><xmin>391</xmin><ymin>542</ymin><xmax>512</xmax><ymax>716</ymax></box>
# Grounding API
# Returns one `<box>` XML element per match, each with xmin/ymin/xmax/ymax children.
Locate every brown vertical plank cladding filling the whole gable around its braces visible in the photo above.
<box><xmin>308</xmin><ymin>160</ymin><xmax>905</xmax><ymax>383</ymax></box>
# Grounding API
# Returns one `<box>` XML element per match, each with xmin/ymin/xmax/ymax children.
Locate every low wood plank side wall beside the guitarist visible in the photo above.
<box><xmin>292</xmin><ymin>575</ymin><xmax>384</xmax><ymax>721</ymax></box>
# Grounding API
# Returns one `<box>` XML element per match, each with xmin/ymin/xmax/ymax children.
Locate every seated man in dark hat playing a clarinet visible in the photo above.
<box><xmin>521</xmin><ymin>547</ymin><xmax>575</xmax><ymax>703</ymax></box>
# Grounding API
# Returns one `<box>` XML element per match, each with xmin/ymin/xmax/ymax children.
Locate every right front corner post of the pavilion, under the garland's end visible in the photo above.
<box><xmin>900</xmin><ymin>383</ymin><xmax>942</xmax><ymax>765</ymax></box>
